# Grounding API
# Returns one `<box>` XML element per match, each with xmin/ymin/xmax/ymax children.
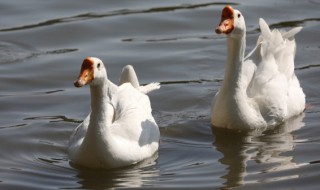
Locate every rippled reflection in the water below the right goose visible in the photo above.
<box><xmin>212</xmin><ymin>114</ymin><xmax>304</xmax><ymax>187</ymax></box>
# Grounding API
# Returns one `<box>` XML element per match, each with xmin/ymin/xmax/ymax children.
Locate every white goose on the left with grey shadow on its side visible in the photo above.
<box><xmin>68</xmin><ymin>57</ymin><xmax>160</xmax><ymax>169</ymax></box>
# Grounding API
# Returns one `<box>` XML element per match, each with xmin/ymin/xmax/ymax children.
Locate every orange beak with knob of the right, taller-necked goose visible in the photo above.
<box><xmin>216</xmin><ymin>5</ymin><xmax>234</xmax><ymax>34</ymax></box>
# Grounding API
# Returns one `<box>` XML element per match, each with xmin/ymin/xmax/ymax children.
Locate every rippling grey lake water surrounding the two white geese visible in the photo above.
<box><xmin>0</xmin><ymin>0</ymin><xmax>320</xmax><ymax>190</ymax></box>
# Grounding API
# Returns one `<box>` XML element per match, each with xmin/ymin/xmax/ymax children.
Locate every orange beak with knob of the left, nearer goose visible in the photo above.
<box><xmin>73</xmin><ymin>58</ymin><xmax>94</xmax><ymax>87</ymax></box>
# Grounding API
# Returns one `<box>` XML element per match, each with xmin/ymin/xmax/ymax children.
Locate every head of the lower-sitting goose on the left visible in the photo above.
<box><xmin>73</xmin><ymin>57</ymin><xmax>107</xmax><ymax>87</ymax></box>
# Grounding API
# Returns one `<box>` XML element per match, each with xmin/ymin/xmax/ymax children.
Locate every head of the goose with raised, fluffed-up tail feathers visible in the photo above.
<box><xmin>216</xmin><ymin>5</ymin><xmax>246</xmax><ymax>38</ymax></box>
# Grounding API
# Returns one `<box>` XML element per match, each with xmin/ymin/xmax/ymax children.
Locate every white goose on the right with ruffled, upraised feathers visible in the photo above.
<box><xmin>211</xmin><ymin>6</ymin><xmax>305</xmax><ymax>130</ymax></box>
